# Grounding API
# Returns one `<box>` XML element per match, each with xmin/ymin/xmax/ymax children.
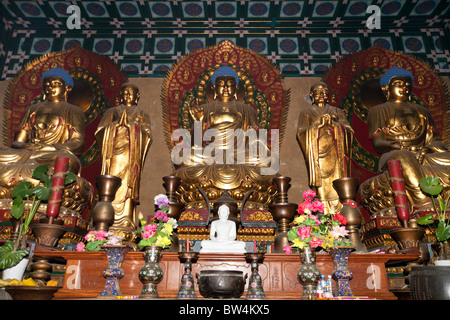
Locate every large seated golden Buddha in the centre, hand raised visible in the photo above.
<box><xmin>172</xmin><ymin>67</ymin><xmax>278</xmax><ymax>209</ymax></box>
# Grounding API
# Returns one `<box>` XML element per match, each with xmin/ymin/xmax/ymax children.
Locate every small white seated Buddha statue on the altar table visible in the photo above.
<box><xmin>200</xmin><ymin>205</ymin><xmax>246</xmax><ymax>253</ymax></box>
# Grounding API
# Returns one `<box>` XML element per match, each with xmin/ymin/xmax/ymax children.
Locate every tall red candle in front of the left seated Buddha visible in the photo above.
<box><xmin>47</xmin><ymin>156</ymin><xmax>69</xmax><ymax>223</ymax></box>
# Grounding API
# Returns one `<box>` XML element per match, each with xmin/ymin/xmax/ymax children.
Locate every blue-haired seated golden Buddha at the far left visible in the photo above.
<box><xmin>0</xmin><ymin>68</ymin><xmax>91</xmax><ymax>205</ymax></box>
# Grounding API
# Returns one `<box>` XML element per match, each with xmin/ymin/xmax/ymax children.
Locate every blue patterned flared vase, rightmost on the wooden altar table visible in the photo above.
<box><xmin>330</xmin><ymin>246</ymin><xmax>355</xmax><ymax>297</ymax></box>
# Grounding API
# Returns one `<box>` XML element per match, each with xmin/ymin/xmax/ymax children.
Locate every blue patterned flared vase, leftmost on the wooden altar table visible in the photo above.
<box><xmin>97</xmin><ymin>245</ymin><xmax>130</xmax><ymax>298</ymax></box>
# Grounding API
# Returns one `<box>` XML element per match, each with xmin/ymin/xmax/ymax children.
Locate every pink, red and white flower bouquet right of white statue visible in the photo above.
<box><xmin>283</xmin><ymin>190</ymin><xmax>352</xmax><ymax>253</ymax></box>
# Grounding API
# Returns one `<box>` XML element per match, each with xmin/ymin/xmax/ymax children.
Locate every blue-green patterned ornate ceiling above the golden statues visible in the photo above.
<box><xmin>0</xmin><ymin>0</ymin><xmax>450</xmax><ymax>80</ymax></box>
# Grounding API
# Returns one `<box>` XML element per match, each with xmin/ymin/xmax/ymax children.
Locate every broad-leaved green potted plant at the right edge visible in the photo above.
<box><xmin>417</xmin><ymin>177</ymin><xmax>450</xmax><ymax>265</ymax></box>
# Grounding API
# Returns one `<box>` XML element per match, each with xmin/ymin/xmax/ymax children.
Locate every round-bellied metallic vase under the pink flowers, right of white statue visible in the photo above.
<box><xmin>297</xmin><ymin>247</ymin><xmax>321</xmax><ymax>300</ymax></box>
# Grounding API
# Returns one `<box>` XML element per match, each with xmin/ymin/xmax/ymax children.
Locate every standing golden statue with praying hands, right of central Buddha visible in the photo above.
<box><xmin>297</xmin><ymin>81</ymin><xmax>354</xmax><ymax>212</ymax></box>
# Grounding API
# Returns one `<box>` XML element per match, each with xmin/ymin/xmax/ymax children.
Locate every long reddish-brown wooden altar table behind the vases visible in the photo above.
<box><xmin>34</xmin><ymin>251</ymin><xmax>419</xmax><ymax>300</ymax></box>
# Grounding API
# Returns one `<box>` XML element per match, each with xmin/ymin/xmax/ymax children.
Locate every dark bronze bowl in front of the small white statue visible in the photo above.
<box><xmin>195</xmin><ymin>270</ymin><xmax>248</xmax><ymax>299</ymax></box>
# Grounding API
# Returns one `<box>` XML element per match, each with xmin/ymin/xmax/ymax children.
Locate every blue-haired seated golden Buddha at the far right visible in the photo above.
<box><xmin>360</xmin><ymin>67</ymin><xmax>450</xmax><ymax>215</ymax></box>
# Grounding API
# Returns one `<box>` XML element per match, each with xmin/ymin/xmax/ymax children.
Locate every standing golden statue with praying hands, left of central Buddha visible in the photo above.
<box><xmin>95</xmin><ymin>82</ymin><xmax>152</xmax><ymax>237</ymax></box>
